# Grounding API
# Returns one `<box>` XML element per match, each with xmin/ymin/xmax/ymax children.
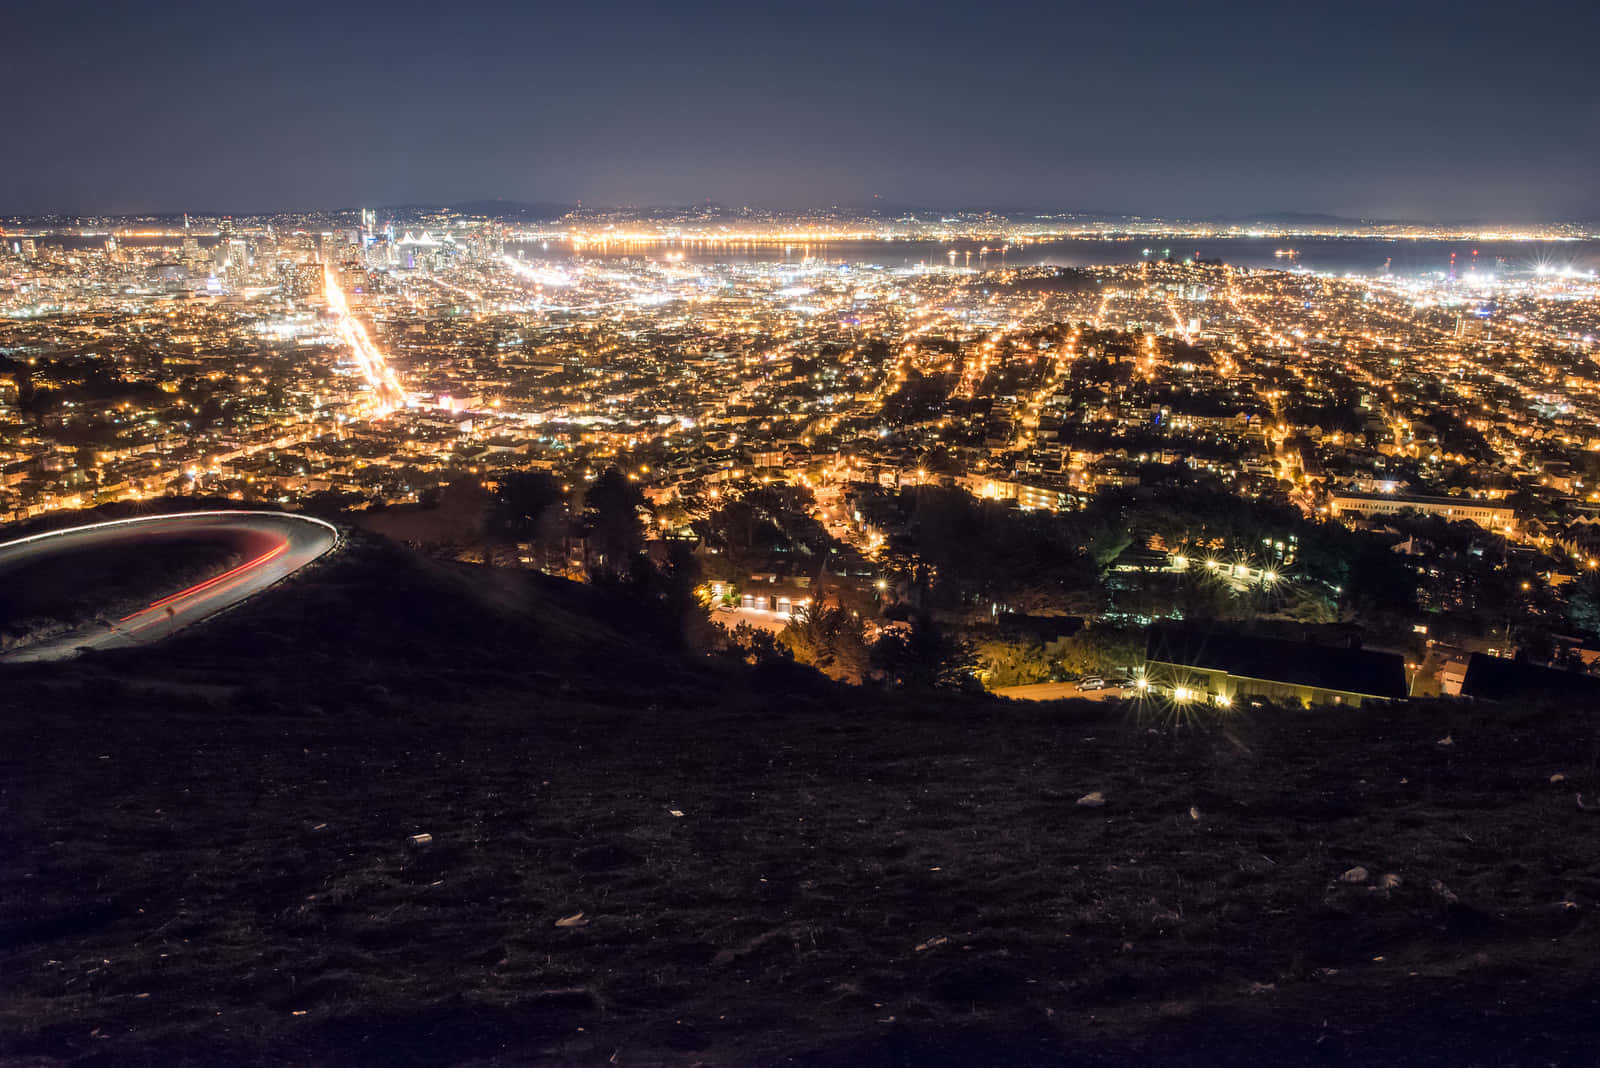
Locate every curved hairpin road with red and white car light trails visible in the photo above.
<box><xmin>0</xmin><ymin>512</ymin><xmax>339</xmax><ymax>662</ymax></box>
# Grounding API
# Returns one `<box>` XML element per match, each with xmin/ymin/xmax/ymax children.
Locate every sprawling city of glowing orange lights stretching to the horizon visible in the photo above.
<box><xmin>0</xmin><ymin>211</ymin><xmax>1600</xmax><ymax>536</ymax></box>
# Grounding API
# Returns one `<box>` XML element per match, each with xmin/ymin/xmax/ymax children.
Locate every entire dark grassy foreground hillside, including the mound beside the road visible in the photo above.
<box><xmin>0</xmin><ymin>540</ymin><xmax>1600</xmax><ymax>1065</ymax></box>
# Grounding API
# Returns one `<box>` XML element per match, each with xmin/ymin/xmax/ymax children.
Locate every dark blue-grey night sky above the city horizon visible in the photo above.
<box><xmin>12</xmin><ymin>0</ymin><xmax>1600</xmax><ymax>221</ymax></box>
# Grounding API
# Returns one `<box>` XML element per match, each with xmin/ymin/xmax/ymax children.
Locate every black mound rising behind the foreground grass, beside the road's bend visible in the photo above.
<box><xmin>72</xmin><ymin>531</ymin><xmax>698</xmax><ymax>710</ymax></box>
